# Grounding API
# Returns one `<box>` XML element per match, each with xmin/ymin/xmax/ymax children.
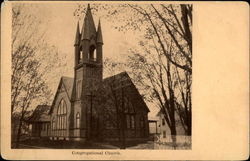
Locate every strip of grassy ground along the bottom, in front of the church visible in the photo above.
<box><xmin>12</xmin><ymin>139</ymin><xmax>191</xmax><ymax>150</ymax></box>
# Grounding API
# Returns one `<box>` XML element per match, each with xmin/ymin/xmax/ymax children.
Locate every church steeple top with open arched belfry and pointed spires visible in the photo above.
<box><xmin>75</xmin><ymin>5</ymin><xmax>103</xmax><ymax>68</ymax></box>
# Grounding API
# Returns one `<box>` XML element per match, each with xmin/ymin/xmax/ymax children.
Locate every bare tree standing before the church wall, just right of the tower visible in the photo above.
<box><xmin>99</xmin><ymin>58</ymin><xmax>129</xmax><ymax>149</ymax></box>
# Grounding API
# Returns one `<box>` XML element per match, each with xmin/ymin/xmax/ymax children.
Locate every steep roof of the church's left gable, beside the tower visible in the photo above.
<box><xmin>49</xmin><ymin>76</ymin><xmax>74</xmax><ymax>114</ymax></box>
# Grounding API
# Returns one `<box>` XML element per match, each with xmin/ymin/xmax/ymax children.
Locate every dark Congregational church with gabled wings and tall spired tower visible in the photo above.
<box><xmin>43</xmin><ymin>5</ymin><xmax>149</xmax><ymax>141</ymax></box>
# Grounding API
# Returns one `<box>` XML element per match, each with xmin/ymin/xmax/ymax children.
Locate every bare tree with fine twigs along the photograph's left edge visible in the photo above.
<box><xmin>11</xmin><ymin>4</ymin><xmax>62</xmax><ymax>147</ymax></box>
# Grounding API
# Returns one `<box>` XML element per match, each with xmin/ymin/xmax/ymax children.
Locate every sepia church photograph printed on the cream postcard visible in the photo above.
<box><xmin>11</xmin><ymin>2</ymin><xmax>193</xmax><ymax>150</ymax></box>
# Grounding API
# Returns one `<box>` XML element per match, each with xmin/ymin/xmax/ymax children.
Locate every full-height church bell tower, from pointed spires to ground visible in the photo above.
<box><xmin>72</xmin><ymin>5</ymin><xmax>103</xmax><ymax>141</ymax></box>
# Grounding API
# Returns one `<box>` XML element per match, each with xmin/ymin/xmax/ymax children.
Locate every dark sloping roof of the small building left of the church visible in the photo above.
<box><xmin>26</xmin><ymin>105</ymin><xmax>50</xmax><ymax>122</ymax></box>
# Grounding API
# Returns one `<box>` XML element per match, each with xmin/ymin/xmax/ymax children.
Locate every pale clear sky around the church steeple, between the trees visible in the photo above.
<box><xmin>17</xmin><ymin>3</ymin><xmax>159</xmax><ymax>116</ymax></box>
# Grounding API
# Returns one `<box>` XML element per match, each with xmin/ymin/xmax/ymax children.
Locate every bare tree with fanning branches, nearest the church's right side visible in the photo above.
<box><xmin>128</xmin><ymin>42</ymin><xmax>177</xmax><ymax>142</ymax></box>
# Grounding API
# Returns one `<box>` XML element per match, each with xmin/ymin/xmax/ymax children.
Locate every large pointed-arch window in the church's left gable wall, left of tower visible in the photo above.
<box><xmin>57</xmin><ymin>99</ymin><xmax>67</xmax><ymax>130</ymax></box>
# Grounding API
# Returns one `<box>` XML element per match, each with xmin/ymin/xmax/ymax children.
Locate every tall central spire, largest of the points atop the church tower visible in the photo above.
<box><xmin>82</xmin><ymin>4</ymin><xmax>96</xmax><ymax>40</ymax></box>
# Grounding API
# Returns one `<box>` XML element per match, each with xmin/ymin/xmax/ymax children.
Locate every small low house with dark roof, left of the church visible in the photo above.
<box><xmin>27</xmin><ymin>105</ymin><xmax>50</xmax><ymax>138</ymax></box>
